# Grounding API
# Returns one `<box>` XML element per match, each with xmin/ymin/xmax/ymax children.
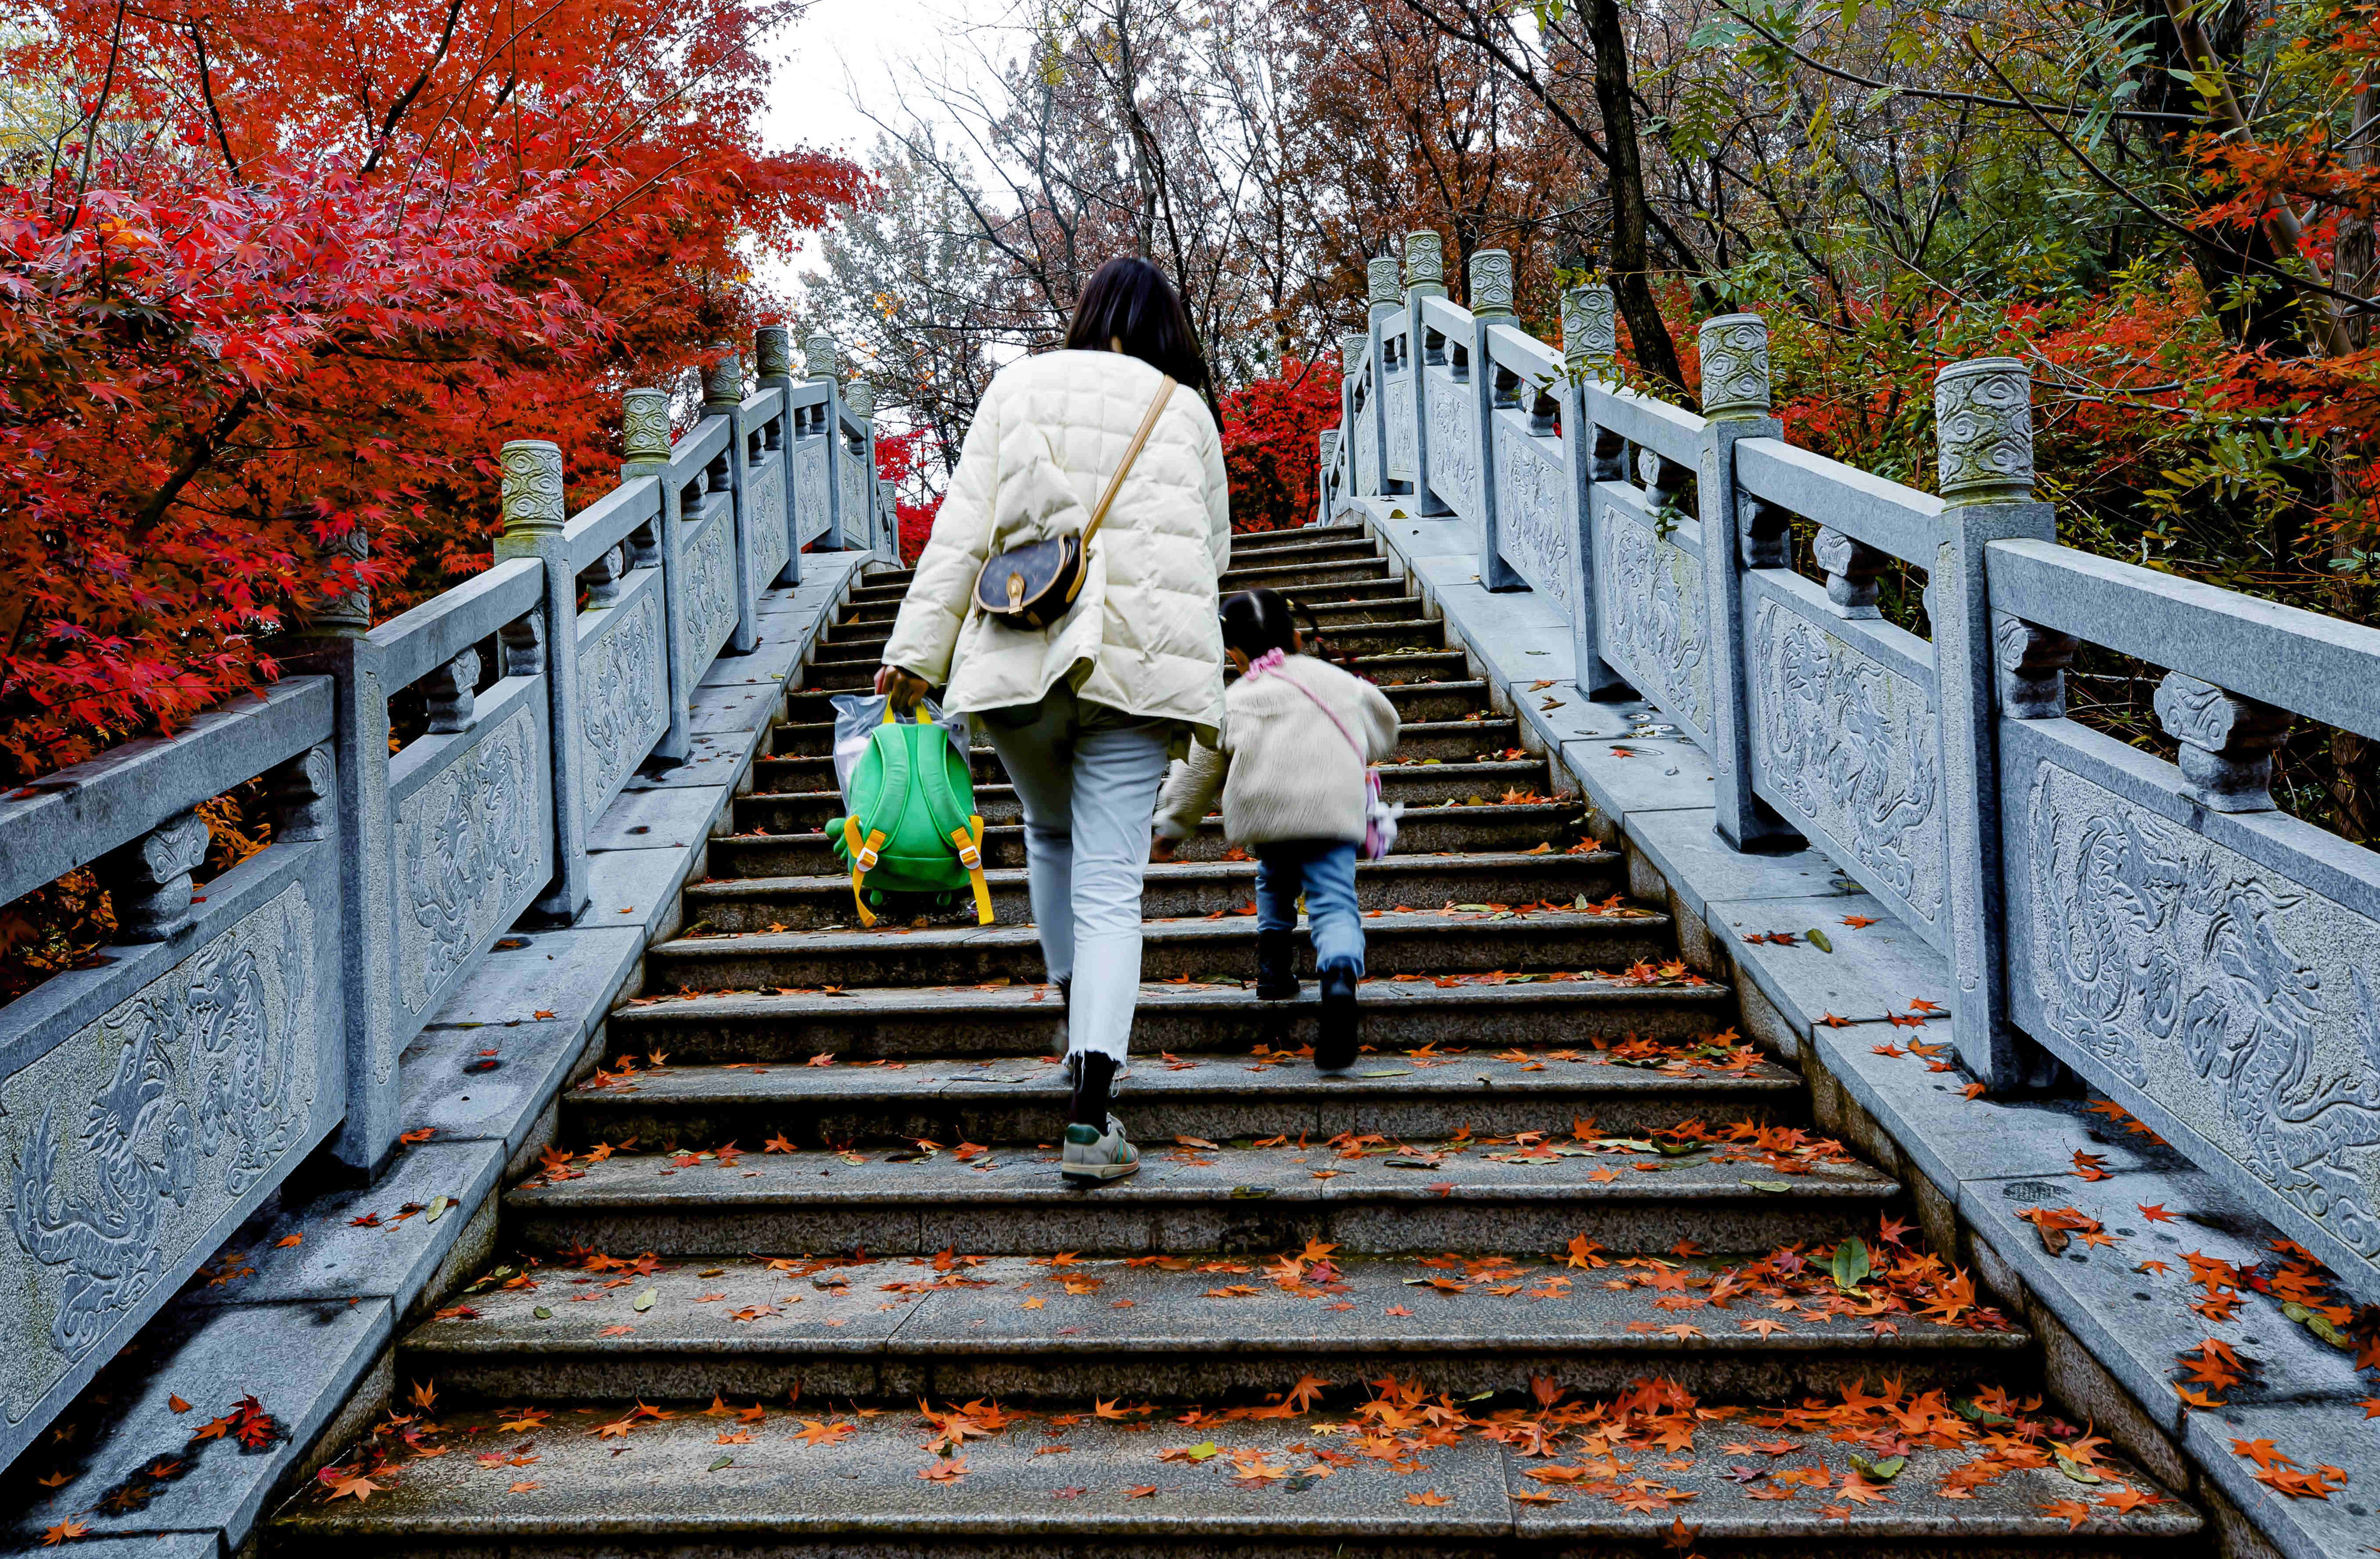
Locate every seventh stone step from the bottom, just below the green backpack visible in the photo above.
<box><xmin>686</xmin><ymin>850</ymin><xmax>1628</xmax><ymax>933</ymax></box>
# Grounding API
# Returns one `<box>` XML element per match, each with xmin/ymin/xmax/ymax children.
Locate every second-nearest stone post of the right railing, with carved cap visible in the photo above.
<box><xmin>1694</xmin><ymin>314</ymin><xmax>1801</xmax><ymax>850</ymax></box>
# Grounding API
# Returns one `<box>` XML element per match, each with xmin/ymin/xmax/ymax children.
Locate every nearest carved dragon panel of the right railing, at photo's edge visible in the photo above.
<box><xmin>2025</xmin><ymin>762</ymin><xmax>2380</xmax><ymax>1259</ymax></box>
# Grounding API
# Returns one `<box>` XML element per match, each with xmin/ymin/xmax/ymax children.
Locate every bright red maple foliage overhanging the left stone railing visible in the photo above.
<box><xmin>0</xmin><ymin>0</ymin><xmax>859</xmax><ymax>778</ymax></box>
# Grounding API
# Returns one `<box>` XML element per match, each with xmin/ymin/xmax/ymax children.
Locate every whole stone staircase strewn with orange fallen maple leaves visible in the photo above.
<box><xmin>266</xmin><ymin>526</ymin><xmax>2199</xmax><ymax>1554</ymax></box>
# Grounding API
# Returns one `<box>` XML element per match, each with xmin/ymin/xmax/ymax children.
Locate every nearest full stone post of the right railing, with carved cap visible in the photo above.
<box><xmin>1925</xmin><ymin>357</ymin><xmax>2056</xmax><ymax>1090</ymax></box>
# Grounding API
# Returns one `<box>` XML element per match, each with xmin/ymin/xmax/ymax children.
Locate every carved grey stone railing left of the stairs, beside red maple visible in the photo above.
<box><xmin>0</xmin><ymin>328</ymin><xmax>892</xmax><ymax>1466</ymax></box>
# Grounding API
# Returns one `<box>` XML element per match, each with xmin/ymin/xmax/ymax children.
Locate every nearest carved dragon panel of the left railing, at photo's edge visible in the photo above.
<box><xmin>0</xmin><ymin>883</ymin><xmax>321</xmax><ymax>1423</ymax></box>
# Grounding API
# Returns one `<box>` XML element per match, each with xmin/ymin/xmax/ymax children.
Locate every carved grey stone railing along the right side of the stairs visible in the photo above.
<box><xmin>1319</xmin><ymin>233</ymin><xmax>2380</xmax><ymax>1300</ymax></box>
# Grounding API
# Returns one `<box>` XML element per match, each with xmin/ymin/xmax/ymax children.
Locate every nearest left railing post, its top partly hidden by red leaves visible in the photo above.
<box><xmin>283</xmin><ymin>526</ymin><xmax>402</xmax><ymax>1181</ymax></box>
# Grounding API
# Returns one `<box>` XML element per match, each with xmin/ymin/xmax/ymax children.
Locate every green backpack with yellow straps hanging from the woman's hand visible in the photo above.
<box><xmin>826</xmin><ymin>707</ymin><xmax>992</xmax><ymax>926</ymax></box>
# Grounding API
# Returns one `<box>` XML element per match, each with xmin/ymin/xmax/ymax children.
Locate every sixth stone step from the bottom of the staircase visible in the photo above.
<box><xmin>645</xmin><ymin>909</ymin><xmax>1673</xmax><ymax>990</ymax></box>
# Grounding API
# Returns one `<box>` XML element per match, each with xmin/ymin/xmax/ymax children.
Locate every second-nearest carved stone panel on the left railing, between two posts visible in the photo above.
<box><xmin>395</xmin><ymin>704</ymin><xmax>547</xmax><ymax>1014</ymax></box>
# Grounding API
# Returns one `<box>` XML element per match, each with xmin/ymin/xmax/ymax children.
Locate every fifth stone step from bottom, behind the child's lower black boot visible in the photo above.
<box><xmin>607</xmin><ymin>978</ymin><xmax>1735</xmax><ymax>1064</ymax></box>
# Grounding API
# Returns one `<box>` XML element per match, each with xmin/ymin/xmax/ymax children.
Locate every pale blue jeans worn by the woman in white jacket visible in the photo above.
<box><xmin>981</xmin><ymin>683</ymin><xmax>1173</xmax><ymax>1066</ymax></box>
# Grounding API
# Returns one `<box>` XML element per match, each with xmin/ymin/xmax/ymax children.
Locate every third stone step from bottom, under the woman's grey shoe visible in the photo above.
<box><xmin>504</xmin><ymin>1142</ymin><xmax>1899</xmax><ymax>1259</ymax></box>
